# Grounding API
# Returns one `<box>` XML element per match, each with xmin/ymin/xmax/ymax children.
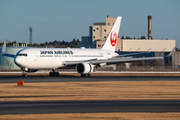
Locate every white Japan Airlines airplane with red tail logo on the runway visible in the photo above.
<box><xmin>2</xmin><ymin>16</ymin><xmax>177</xmax><ymax>77</ymax></box>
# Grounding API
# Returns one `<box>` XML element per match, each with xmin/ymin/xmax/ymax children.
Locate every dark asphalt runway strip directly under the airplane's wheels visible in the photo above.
<box><xmin>0</xmin><ymin>76</ymin><xmax>180</xmax><ymax>83</ymax></box>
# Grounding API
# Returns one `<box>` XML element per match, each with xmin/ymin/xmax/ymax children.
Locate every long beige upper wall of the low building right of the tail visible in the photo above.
<box><xmin>122</xmin><ymin>39</ymin><xmax>175</xmax><ymax>52</ymax></box>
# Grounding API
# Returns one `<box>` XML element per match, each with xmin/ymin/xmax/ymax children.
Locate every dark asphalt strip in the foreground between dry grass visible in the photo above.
<box><xmin>0</xmin><ymin>100</ymin><xmax>180</xmax><ymax>115</ymax></box>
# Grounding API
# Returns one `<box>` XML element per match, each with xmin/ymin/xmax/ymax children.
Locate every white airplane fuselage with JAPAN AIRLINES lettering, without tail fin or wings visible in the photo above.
<box><xmin>14</xmin><ymin>48</ymin><xmax>118</xmax><ymax>69</ymax></box>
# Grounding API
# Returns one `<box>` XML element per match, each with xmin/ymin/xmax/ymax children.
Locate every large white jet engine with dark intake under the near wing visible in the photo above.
<box><xmin>76</xmin><ymin>62</ymin><xmax>94</xmax><ymax>74</ymax></box>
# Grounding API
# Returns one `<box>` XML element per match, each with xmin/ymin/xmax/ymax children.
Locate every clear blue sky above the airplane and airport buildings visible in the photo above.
<box><xmin>0</xmin><ymin>0</ymin><xmax>180</xmax><ymax>46</ymax></box>
